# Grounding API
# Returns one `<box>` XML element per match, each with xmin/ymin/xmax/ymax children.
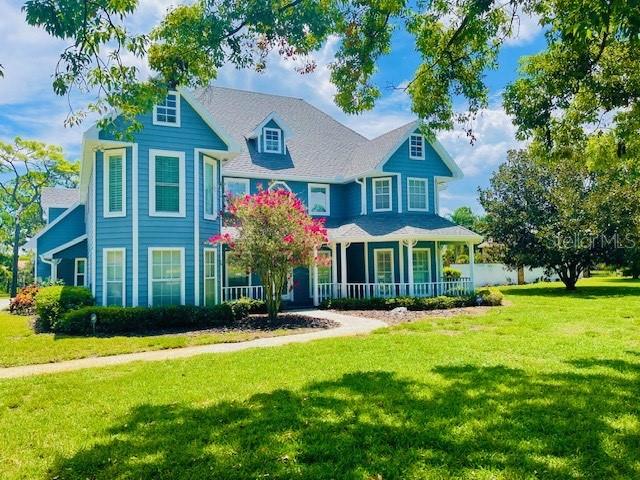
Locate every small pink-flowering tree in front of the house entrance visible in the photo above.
<box><xmin>209</xmin><ymin>189</ymin><xmax>327</xmax><ymax>319</ymax></box>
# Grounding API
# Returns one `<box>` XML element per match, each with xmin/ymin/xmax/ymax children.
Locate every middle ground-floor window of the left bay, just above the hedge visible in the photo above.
<box><xmin>149</xmin><ymin>248</ymin><xmax>184</xmax><ymax>305</ymax></box>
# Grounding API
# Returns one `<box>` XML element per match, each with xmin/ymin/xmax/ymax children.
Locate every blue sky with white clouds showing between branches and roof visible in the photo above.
<box><xmin>0</xmin><ymin>0</ymin><xmax>544</xmax><ymax>214</ymax></box>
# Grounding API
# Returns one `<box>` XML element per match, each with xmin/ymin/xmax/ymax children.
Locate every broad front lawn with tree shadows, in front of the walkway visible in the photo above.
<box><xmin>0</xmin><ymin>279</ymin><xmax>640</xmax><ymax>480</ymax></box>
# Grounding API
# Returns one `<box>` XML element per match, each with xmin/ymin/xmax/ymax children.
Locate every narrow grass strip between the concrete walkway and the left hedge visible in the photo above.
<box><xmin>0</xmin><ymin>312</ymin><xmax>292</xmax><ymax>367</ymax></box>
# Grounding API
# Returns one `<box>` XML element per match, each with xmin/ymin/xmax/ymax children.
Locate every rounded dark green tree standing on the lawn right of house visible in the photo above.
<box><xmin>480</xmin><ymin>129</ymin><xmax>640</xmax><ymax>290</ymax></box>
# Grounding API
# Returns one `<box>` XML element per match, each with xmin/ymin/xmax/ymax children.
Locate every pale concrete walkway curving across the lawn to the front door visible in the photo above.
<box><xmin>0</xmin><ymin>310</ymin><xmax>387</xmax><ymax>379</ymax></box>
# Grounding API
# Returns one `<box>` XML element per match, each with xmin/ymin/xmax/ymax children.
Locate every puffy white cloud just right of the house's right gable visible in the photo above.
<box><xmin>438</xmin><ymin>108</ymin><xmax>521</xmax><ymax>177</ymax></box>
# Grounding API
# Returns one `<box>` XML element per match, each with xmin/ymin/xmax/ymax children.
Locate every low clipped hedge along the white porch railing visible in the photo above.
<box><xmin>320</xmin><ymin>296</ymin><xmax>476</xmax><ymax>311</ymax></box>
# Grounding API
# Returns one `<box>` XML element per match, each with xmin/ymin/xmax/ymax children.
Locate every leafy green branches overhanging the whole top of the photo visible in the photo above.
<box><xmin>12</xmin><ymin>0</ymin><xmax>640</xmax><ymax>143</ymax></box>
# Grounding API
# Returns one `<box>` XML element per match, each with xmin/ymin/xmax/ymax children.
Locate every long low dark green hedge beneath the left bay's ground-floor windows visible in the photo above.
<box><xmin>53</xmin><ymin>303</ymin><xmax>238</xmax><ymax>335</ymax></box>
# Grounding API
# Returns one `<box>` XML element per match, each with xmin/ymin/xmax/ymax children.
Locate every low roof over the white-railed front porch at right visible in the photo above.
<box><xmin>327</xmin><ymin>212</ymin><xmax>482</xmax><ymax>243</ymax></box>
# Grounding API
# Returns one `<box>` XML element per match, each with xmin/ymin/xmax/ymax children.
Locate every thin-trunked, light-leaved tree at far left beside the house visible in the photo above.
<box><xmin>0</xmin><ymin>137</ymin><xmax>79</xmax><ymax>296</ymax></box>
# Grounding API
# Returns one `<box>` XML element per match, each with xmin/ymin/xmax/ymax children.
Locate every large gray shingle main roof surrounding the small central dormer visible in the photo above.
<box><xmin>193</xmin><ymin>87</ymin><xmax>430</xmax><ymax>180</ymax></box>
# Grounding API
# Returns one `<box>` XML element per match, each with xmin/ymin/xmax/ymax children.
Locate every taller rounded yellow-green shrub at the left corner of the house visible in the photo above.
<box><xmin>35</xmin><ymin>285</ymin><xmax>93</xmax><ymax>331</ymax></box>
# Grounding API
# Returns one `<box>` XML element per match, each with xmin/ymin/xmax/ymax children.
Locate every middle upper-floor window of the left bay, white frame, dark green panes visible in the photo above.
<box><xmin>149</xmin><ymin>150</ymin><xmax>185</xmax><ymax>217</ymax></box>
